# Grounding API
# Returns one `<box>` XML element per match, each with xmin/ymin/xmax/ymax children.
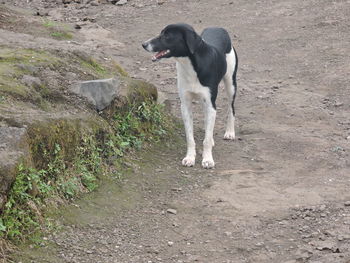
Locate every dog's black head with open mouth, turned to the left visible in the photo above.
<box><xmin>142</xmin><ymin>24</ymin><xmax>202</xmax><ymax>61</ymax></box>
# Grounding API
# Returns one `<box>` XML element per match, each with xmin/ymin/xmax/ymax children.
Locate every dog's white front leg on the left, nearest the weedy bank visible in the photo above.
<box><xmin>180</xmin><ymin>93</ymin><xmax>196</xmax><ymax>166</ymax></box>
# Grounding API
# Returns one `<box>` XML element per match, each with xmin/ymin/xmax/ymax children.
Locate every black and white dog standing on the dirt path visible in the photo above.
<box><xmin>142</xmin><ymin>24</ymin><xmax>238</xmax><ymax>168</ymax></box>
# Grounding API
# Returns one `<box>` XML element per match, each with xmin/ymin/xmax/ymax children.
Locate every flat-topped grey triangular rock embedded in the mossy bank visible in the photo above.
<box><xmin>71</xmin><ymin>78</ymin><xmax>120</xmax><ymax>111</ymax></box>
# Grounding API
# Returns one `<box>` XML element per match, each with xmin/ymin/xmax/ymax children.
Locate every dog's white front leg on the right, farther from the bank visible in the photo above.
<box><xmin>202</xmin><ymin>99</ymin><xmax>216</xmax><ymax>169</ymax></box>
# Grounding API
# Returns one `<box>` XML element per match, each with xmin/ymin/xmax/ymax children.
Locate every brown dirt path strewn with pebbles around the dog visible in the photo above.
<box><xmin>2</xmin><ymin>0</ymin><xmax>350</xmax><ymax>263</ymax></box>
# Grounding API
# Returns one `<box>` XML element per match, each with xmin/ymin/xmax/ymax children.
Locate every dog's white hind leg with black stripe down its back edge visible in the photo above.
<box><xmin>224</xmin><ymin>48</ymin><xmax>238</xmax><ymax>140</ymax></box>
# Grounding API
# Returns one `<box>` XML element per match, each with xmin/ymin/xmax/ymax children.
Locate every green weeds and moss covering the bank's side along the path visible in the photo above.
<box><xmin>0</xmin><ymin>100</ymin><xmax>173</xmax><ymax>243</ymax></box>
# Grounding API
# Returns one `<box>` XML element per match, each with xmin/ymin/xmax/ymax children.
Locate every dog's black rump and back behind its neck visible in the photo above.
<box><xmin>201</xmin><ymin>27</ymin><xmax>232</xmax><ymax>54</ymax></box>
